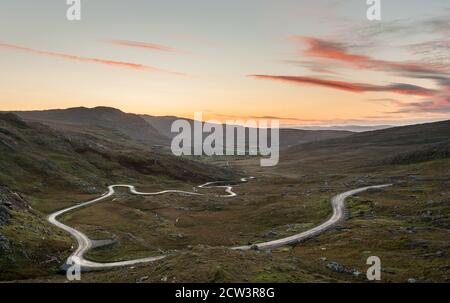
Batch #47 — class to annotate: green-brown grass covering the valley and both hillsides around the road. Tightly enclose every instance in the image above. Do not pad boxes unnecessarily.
[0,114,450,282]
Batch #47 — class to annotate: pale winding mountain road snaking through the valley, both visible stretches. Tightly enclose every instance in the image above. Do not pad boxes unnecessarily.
[47,177,391,271]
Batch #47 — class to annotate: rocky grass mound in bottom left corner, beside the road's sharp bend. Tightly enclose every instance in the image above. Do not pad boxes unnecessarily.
[0,186,71,281]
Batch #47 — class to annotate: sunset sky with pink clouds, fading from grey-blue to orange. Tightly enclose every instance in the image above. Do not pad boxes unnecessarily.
[0,0,450,126]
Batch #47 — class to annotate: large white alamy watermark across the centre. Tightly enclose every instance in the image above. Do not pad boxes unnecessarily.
[171,112,280,166]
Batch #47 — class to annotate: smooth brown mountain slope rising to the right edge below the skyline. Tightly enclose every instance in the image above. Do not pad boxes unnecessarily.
[281,120,450,169]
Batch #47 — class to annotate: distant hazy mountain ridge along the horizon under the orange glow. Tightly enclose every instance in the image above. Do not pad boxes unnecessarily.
[1,106,352,149]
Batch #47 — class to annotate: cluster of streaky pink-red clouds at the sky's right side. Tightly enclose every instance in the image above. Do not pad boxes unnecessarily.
[251,36,450,113]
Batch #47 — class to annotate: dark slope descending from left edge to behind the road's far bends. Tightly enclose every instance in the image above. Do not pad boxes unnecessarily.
[0,114,236,194]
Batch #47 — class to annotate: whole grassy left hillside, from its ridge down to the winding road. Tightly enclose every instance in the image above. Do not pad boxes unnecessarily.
[0,113,237,280]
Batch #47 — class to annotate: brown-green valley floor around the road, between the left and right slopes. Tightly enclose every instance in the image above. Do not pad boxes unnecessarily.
[5,158,450,282]
